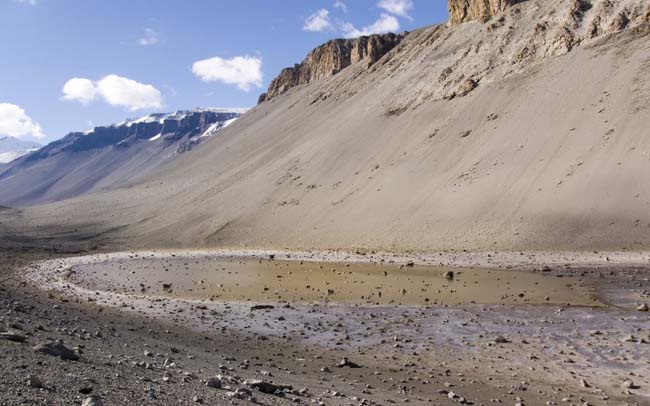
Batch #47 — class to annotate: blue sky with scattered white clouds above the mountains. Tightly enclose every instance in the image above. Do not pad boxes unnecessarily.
[0,0,447,143]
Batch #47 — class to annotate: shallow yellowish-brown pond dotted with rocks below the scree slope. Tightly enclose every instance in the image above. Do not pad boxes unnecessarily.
[69,257,601,306]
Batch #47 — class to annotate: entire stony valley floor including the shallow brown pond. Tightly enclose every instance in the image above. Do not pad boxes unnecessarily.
[0,251,650,405]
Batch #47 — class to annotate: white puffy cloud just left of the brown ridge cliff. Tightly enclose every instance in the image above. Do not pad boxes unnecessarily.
[192,56,263,91]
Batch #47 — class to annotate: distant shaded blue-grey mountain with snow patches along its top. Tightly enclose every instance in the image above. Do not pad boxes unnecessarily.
[0,109,245,206]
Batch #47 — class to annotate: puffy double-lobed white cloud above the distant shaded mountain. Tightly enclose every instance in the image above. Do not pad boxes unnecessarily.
[63,75,163,111]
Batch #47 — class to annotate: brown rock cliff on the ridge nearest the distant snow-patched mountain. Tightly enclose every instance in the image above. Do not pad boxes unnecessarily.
[259,33,403,103]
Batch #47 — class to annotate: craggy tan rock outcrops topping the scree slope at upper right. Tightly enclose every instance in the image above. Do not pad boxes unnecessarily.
[306,0,650,104]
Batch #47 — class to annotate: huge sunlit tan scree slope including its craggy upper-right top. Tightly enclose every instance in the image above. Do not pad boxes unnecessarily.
[2,0,650,251]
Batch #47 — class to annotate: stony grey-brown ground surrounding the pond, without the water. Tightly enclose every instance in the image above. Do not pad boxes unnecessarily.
[0,246,650,405]
